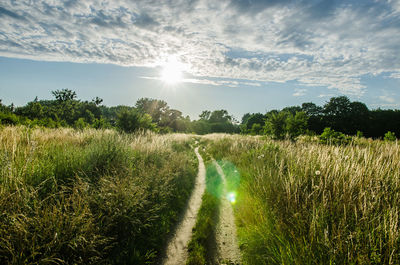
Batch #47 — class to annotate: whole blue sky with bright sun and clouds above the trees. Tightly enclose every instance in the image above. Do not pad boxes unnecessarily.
[0,0,400,119]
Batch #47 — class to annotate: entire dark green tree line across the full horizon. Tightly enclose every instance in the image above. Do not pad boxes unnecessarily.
[0,89,400,139]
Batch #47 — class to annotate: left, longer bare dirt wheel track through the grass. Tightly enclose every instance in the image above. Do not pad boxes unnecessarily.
[163,147,206,265]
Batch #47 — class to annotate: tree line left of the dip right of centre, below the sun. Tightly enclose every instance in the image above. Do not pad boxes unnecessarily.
[0,89,239,134]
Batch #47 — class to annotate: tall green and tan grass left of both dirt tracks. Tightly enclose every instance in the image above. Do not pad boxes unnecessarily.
[0,127,197,264]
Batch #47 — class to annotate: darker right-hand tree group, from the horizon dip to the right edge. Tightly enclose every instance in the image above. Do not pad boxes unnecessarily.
[240,96,400,139]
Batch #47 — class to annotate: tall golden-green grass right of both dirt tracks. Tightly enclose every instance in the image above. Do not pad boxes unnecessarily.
[206,135,400,264]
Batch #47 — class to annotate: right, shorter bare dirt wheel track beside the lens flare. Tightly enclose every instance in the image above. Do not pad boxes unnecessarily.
[214,161,241,264]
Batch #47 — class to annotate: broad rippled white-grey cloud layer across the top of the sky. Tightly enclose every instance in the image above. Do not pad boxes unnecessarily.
[0,0,400,96]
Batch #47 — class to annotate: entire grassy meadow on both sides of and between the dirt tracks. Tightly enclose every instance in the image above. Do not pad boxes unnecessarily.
[0,126,400,264]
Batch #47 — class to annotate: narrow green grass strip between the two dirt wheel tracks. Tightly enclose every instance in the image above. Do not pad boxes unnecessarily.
[186,162,222,265]
